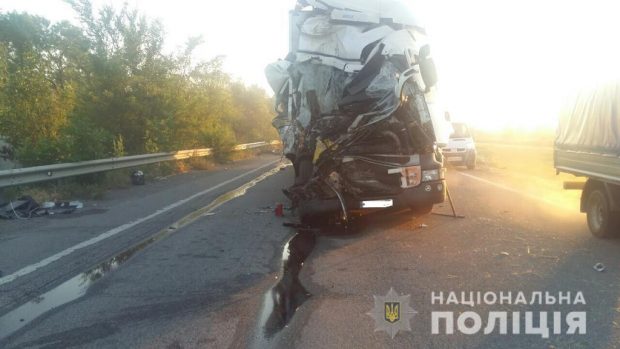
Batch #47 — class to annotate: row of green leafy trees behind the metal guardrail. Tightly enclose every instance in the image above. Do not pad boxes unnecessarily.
[0,0,276,166]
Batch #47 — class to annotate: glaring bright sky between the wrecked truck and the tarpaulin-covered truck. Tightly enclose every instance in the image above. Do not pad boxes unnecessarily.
[414,0,620,130]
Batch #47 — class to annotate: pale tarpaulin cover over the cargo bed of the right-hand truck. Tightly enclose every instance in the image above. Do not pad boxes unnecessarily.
[555,82,620,156]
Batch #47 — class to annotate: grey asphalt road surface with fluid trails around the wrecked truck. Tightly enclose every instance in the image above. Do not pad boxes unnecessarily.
[0,156,620,348]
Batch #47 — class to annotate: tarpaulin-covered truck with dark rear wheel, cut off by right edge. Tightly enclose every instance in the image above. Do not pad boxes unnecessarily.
[554,82,620,238]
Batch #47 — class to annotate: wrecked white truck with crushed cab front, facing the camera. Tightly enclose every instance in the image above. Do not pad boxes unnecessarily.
[266,0,450,223]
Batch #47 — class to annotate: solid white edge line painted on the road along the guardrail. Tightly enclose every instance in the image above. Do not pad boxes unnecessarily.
[0,160,280,285]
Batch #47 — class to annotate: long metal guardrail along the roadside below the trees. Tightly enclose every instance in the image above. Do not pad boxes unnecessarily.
[0,142,274,188]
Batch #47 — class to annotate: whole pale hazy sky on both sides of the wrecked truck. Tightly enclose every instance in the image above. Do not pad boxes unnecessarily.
[0,0,620,129]
